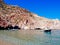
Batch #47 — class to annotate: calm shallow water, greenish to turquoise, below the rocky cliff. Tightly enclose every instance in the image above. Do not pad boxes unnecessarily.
[0,30,60,45]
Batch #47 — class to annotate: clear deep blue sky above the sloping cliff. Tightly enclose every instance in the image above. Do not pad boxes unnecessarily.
[4,0,60,19]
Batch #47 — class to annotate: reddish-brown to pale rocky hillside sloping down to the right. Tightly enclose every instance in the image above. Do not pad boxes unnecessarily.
[0,0,60,29]
